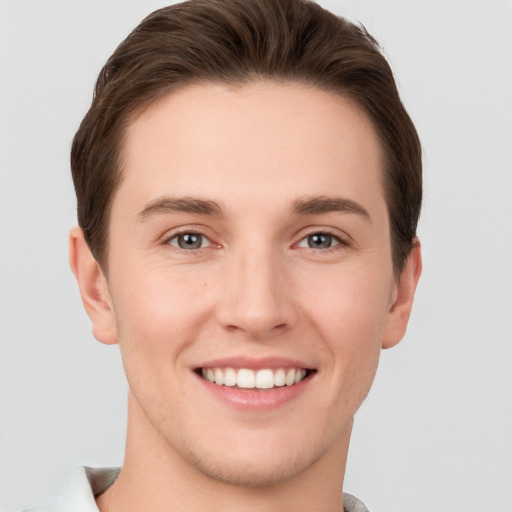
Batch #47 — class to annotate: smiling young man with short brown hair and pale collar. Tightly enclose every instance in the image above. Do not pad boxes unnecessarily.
[26,0,421,512]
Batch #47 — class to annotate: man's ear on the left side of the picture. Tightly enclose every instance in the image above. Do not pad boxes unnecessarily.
[69,226,117,345]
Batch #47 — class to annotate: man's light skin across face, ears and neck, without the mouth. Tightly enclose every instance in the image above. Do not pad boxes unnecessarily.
[70,82,421,512]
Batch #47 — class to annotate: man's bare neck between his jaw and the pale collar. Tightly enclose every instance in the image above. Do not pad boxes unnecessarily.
[97,397,351,512]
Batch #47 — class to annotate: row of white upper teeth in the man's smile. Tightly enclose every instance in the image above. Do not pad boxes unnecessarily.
[202,368,306,389]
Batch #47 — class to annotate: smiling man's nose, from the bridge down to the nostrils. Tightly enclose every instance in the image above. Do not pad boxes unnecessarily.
[217,245,298,341]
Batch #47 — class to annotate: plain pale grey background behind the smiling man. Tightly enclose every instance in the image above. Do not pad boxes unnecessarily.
[0,0,512,512]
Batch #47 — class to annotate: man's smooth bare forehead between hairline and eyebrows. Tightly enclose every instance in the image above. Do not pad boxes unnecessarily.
[114,81,383,214]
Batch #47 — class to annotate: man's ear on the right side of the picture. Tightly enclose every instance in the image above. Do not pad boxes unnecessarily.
[382,240,422,348]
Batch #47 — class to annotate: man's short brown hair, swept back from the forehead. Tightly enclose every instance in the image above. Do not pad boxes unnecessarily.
[71,0,422,275]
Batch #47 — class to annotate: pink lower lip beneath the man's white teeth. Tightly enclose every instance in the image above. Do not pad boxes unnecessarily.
[197,374,314,411]
